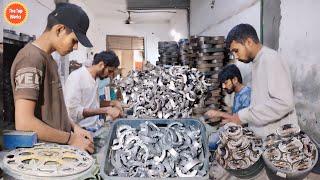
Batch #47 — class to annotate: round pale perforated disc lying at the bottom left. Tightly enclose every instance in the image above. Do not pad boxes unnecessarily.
[3,144,95,179]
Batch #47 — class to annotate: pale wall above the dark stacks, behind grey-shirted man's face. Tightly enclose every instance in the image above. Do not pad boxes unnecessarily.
[190,0,260,86]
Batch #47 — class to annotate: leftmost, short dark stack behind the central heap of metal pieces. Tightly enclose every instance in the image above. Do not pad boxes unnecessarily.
[157,41,179,65]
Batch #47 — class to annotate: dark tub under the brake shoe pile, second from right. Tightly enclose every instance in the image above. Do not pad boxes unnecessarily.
[226,157,264,179]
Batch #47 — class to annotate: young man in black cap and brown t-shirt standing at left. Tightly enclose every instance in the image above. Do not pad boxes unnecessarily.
[11,3,94,153]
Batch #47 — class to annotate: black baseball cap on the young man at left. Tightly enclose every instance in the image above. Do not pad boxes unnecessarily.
[50,3,93,47]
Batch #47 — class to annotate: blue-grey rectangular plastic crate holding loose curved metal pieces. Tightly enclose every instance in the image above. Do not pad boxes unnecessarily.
[98,119,209,180]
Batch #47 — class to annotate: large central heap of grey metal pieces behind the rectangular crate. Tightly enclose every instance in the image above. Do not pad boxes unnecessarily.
[115,66,210,119]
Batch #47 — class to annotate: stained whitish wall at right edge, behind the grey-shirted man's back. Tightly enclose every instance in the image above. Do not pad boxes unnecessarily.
[278,0,320,143]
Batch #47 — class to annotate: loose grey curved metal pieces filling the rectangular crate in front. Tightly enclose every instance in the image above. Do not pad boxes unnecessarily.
[110,121,207,178]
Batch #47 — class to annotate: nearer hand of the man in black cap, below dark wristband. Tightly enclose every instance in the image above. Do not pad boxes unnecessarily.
[68,133,94,153]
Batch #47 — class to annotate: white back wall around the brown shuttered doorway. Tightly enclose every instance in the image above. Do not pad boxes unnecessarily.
[70,0,188,64]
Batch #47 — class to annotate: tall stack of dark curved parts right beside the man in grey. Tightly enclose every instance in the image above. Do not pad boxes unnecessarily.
[190,36,225,114]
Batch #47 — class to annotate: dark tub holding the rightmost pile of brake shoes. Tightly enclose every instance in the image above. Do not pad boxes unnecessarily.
[262,149,318,180]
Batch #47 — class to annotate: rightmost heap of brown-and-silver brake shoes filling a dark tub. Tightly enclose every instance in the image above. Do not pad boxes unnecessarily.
[263,124,317,171]
